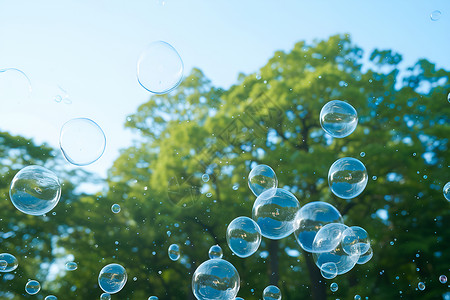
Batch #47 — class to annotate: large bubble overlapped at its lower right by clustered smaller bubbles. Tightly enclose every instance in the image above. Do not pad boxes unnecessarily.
[294,201,344,252]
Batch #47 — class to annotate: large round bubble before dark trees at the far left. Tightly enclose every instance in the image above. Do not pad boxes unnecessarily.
[9,166,61,216]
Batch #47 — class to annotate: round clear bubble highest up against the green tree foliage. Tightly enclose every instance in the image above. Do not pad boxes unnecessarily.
[320,100,358,138]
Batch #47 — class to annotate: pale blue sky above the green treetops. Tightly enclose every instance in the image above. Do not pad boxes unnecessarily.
[0,0,450,176]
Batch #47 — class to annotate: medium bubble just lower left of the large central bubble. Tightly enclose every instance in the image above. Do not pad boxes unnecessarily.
[227,217,261,258]
